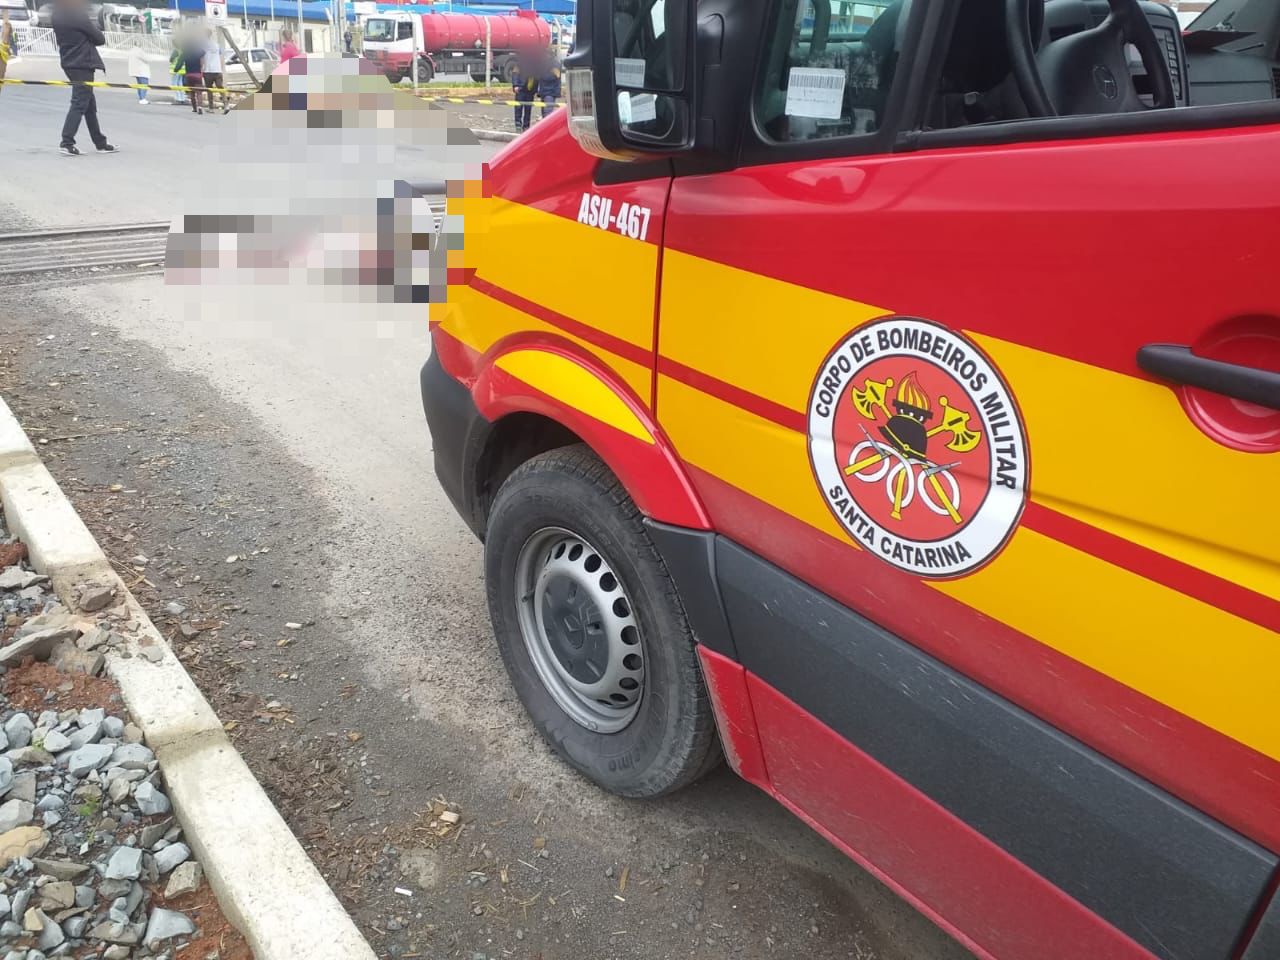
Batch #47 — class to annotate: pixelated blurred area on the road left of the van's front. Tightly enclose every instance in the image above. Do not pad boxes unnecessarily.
[165,54,484,308]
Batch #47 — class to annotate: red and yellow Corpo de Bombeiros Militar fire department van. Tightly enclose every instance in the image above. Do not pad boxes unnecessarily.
[422,0,1280,960]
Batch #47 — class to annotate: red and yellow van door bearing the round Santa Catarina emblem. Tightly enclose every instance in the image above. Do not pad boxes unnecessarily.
[657,0,1280,959]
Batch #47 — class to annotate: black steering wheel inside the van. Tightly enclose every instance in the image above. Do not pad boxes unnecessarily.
[1005,0,1175,116]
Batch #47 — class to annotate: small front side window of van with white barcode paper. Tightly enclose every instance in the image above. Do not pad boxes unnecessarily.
[755,0,906,141]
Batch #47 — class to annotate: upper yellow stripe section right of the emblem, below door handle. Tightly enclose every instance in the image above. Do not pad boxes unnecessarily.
[969,333,1280,601]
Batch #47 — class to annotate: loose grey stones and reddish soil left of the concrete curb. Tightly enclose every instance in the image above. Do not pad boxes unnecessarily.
[0,520,250,960]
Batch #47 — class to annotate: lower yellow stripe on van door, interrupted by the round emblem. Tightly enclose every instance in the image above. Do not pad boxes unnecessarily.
[658,376,1280,759]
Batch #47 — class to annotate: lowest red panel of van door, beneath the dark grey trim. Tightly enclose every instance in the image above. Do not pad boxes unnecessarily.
[746,675,1152,960]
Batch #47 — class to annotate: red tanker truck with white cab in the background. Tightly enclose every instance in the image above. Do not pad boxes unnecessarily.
[365,10,552,82]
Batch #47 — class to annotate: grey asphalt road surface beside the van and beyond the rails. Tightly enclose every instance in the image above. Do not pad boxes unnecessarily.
[0,71,968,960]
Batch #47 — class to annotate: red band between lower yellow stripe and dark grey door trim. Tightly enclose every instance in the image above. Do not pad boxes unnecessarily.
[690,467,1280,849]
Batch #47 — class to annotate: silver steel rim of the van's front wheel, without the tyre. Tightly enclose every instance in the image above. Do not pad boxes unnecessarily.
[516,527,645,733]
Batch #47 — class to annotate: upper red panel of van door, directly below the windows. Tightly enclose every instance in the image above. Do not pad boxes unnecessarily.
[667,127,1280,376]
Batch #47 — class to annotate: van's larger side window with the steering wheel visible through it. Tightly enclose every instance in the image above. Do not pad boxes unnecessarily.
[927,0,1280,129]
